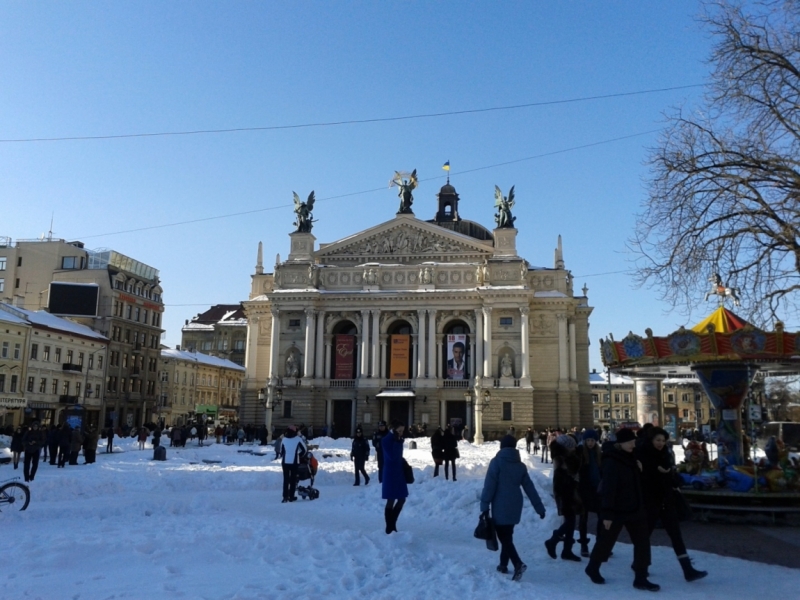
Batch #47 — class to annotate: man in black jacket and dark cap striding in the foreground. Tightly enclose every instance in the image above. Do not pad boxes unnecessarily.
[585,429,661,592]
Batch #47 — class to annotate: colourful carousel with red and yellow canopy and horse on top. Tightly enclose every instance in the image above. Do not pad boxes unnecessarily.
[600,284,800,522]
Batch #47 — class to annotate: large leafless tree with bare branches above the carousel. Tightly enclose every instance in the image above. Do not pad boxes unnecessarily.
[629,0,800,323]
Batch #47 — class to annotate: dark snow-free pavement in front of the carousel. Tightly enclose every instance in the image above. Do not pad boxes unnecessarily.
[576,518,800,569]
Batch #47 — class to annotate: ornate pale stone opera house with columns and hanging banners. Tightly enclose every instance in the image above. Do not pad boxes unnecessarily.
[240,183,593,441]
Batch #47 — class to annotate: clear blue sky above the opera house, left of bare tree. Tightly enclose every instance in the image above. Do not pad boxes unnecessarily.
[0,0,736,368]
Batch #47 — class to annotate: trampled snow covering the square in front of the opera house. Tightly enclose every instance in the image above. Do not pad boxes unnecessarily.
[0,438,800,600]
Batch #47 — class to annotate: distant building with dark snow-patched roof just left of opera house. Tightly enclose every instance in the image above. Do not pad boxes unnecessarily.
[181,303,247,366]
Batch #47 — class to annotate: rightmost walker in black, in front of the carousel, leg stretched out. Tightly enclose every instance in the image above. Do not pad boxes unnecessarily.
[636,427,708,581]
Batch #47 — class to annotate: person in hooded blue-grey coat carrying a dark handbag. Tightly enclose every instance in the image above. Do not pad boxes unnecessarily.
[481,435,545,581]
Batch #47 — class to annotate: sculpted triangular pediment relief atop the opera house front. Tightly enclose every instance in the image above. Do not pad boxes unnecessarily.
[317,220,492,261]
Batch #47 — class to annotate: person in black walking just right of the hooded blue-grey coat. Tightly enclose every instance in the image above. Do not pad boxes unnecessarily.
[544,434,581,562]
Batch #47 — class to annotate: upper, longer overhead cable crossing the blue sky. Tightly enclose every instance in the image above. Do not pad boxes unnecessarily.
[0,83,704,144]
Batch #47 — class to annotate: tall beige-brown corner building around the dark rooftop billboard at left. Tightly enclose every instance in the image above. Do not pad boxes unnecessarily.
[0,238,164,428]
